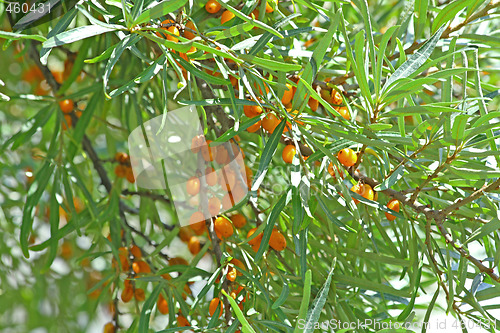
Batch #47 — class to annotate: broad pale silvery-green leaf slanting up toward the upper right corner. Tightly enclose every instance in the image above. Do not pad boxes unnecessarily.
[382,25,445,93]
